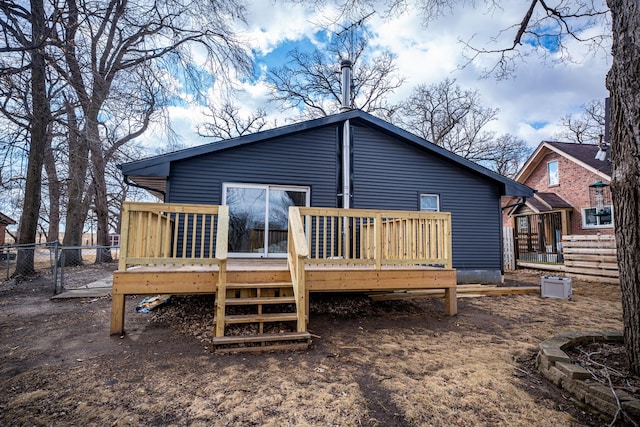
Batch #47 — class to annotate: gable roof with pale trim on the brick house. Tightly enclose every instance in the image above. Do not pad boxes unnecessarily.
[515,141,611,183]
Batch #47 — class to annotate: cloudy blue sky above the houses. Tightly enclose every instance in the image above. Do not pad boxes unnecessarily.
[146,0,610,154]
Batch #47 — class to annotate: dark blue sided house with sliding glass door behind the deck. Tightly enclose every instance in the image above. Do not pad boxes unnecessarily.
[120,110,533,283]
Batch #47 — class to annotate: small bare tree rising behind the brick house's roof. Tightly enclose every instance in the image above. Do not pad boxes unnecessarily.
[555,99,604,144]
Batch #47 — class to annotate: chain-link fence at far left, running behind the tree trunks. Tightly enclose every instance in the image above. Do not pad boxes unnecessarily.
[0,242,120,294]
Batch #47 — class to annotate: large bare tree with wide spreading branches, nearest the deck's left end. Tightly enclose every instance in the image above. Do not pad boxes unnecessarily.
[42,0,248,260]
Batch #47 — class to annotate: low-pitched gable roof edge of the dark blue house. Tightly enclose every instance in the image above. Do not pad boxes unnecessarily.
[118,110,533,198]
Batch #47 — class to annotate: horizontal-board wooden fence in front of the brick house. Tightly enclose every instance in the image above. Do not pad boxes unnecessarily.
[562,235,619,284]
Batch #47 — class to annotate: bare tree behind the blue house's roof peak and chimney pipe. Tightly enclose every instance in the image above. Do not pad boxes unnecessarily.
[267,25,404,118]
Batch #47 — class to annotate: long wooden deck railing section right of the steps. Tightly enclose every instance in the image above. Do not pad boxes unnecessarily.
[290,207,452,269]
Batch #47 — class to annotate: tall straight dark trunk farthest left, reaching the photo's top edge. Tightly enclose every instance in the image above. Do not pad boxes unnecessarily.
[15,0,50,275]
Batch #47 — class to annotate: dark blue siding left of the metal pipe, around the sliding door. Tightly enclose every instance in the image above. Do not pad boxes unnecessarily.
[167,126,337,207]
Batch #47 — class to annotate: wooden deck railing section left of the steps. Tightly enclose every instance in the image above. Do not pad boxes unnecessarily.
[118,202,229,271]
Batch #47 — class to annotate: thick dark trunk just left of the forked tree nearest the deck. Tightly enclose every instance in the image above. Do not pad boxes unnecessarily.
[62,102,89,265]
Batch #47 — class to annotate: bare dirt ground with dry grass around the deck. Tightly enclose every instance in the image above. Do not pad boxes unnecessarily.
[0,269,622,426]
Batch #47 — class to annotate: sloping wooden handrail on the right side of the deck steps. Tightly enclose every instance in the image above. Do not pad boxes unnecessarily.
[287,206,309,332]
